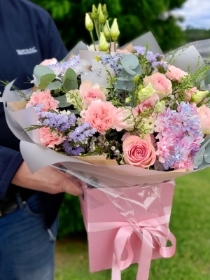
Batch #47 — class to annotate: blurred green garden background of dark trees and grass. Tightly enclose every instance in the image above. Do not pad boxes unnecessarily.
[32,0,210,280]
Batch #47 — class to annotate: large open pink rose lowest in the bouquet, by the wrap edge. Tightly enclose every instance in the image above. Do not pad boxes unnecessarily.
[123,135,156,168]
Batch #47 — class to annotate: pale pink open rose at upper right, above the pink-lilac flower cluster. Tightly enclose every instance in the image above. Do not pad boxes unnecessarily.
[143,73,172,99]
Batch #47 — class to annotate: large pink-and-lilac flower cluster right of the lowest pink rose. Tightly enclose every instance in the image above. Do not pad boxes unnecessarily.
[155,102,204,170]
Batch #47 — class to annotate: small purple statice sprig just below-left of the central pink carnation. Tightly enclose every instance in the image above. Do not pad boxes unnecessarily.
[69,123,97,143]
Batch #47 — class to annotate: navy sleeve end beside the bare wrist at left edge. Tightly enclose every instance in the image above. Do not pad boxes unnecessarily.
[0,146,23,200]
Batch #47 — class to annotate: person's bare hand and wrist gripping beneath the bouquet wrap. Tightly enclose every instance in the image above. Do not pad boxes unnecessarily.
[12,162,82,195]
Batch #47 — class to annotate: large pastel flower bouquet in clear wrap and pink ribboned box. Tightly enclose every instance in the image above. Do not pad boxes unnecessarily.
[4,4,210,280]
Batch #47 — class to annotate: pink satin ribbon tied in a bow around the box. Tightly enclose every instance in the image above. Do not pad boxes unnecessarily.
[88,215,176,280]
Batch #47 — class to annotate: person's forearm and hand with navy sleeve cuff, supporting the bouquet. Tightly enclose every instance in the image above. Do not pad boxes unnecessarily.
[0,146,82,200]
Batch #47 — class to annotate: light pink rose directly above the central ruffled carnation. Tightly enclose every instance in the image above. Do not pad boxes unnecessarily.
[79,81,106,107]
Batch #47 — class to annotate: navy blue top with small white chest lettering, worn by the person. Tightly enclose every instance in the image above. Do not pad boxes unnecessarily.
[0,0,67,227]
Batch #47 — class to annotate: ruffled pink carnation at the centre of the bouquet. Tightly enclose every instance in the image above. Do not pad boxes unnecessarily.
[80,100,117,134]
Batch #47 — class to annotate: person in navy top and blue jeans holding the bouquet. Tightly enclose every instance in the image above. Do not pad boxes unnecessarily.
[0,0,81,280]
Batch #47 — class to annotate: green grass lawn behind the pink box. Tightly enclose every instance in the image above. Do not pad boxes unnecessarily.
[55,169,210,280]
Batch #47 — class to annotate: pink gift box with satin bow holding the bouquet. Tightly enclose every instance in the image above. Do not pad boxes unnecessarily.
[80,181,176,280]
